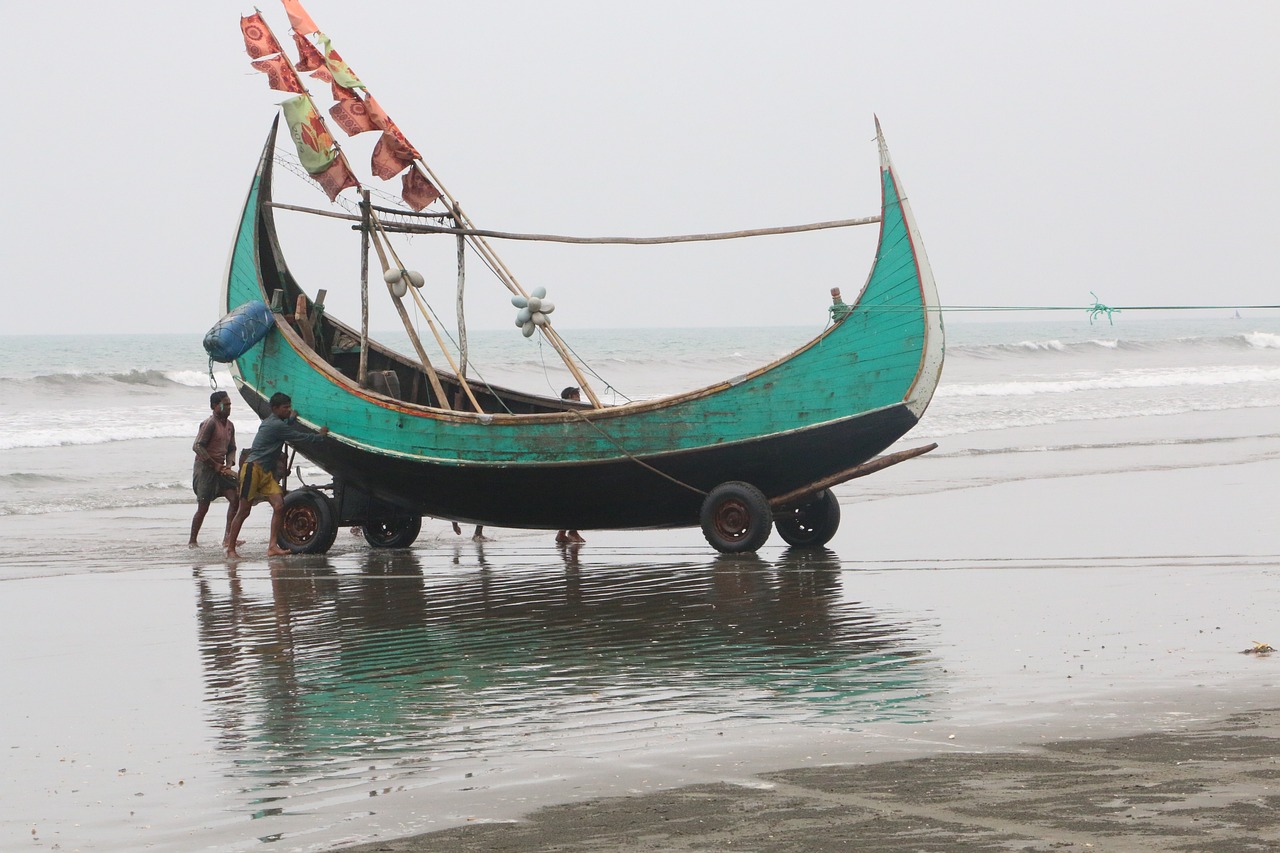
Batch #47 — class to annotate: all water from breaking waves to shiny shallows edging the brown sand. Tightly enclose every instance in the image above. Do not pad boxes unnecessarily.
[0,310,1280,853]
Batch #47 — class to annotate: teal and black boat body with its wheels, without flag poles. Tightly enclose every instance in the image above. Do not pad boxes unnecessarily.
[224,111,943,552]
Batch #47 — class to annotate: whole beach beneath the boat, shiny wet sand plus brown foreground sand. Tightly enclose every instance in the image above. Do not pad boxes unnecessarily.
[0,409,1280,850]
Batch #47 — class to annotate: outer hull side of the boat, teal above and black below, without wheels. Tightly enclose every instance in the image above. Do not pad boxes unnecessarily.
[224,117,942,529]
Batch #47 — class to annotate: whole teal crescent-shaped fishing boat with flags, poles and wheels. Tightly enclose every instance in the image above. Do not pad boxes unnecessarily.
[217,0,943,552]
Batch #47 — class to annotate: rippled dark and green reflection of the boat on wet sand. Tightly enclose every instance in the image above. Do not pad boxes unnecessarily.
[198,552,932,772]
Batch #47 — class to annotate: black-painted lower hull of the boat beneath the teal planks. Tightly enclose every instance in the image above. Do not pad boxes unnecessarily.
[242,386,916,530]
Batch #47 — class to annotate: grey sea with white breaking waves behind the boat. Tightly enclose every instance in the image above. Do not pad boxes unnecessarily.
[0,311,1280,517]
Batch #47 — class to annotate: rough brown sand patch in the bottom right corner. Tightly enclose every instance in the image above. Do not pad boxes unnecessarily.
[346,710,1280,853]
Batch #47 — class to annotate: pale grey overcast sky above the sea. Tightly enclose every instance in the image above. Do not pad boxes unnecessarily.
[0,0,1280,334]
